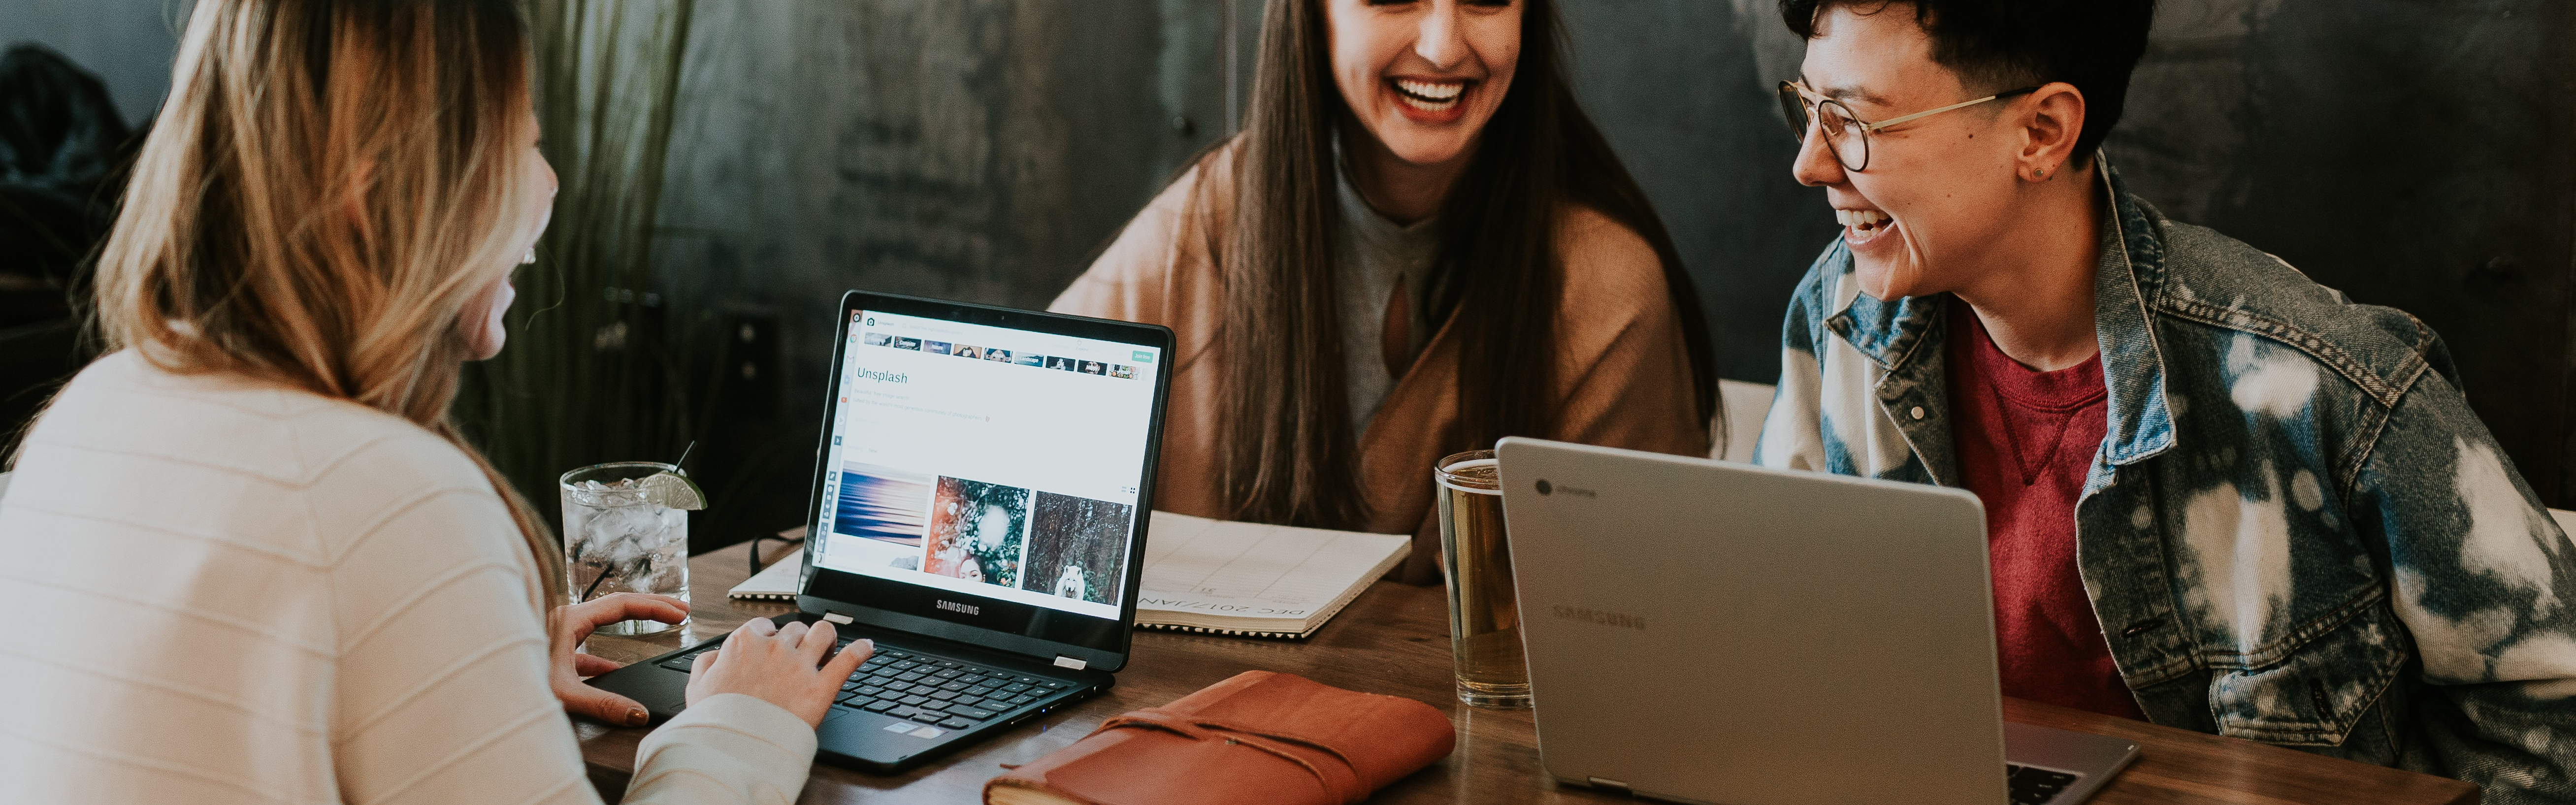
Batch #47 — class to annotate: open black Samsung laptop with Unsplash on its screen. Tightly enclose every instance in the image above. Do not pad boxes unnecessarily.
[590,290,1172,772]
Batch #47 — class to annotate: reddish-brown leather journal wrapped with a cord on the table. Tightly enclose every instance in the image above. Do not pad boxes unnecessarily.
[984,671,1458,805]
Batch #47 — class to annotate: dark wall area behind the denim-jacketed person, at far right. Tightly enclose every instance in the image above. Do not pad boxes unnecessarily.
[2110,0,2576,504]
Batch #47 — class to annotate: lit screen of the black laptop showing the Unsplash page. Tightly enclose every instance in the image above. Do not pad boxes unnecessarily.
[814,311,1162,617]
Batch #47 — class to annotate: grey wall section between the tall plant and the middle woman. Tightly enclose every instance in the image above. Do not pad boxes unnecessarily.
[657,0,1249,535]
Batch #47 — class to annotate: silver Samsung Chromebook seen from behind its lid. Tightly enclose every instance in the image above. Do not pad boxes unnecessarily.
[1497,437,2138,805]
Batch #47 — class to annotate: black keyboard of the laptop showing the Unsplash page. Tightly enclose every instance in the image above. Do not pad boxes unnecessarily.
[662,641,1072,731]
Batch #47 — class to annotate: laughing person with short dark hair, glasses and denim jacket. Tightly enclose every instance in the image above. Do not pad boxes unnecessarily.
[1754,0,2576,803]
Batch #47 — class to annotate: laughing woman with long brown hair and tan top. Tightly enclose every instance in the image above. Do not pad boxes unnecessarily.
[1053,0,1716,584]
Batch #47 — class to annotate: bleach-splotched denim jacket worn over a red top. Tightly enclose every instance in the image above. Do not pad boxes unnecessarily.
[1754,162,2576,805]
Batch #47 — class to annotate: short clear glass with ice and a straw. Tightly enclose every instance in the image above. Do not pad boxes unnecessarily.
[559,460,688,635]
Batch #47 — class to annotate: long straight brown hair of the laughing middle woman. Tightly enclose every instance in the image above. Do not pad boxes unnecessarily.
[1201,0,1716,527]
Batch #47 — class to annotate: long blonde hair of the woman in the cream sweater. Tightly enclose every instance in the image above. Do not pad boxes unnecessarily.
[98,0,567,602]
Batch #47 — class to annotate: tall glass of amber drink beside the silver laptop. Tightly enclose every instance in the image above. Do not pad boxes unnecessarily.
[1432,450,1530,710]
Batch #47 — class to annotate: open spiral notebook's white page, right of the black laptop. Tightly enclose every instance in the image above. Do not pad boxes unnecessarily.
[1136,512,1414,638]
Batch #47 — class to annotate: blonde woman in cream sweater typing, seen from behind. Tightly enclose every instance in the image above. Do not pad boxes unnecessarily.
[0,0,868,803]
